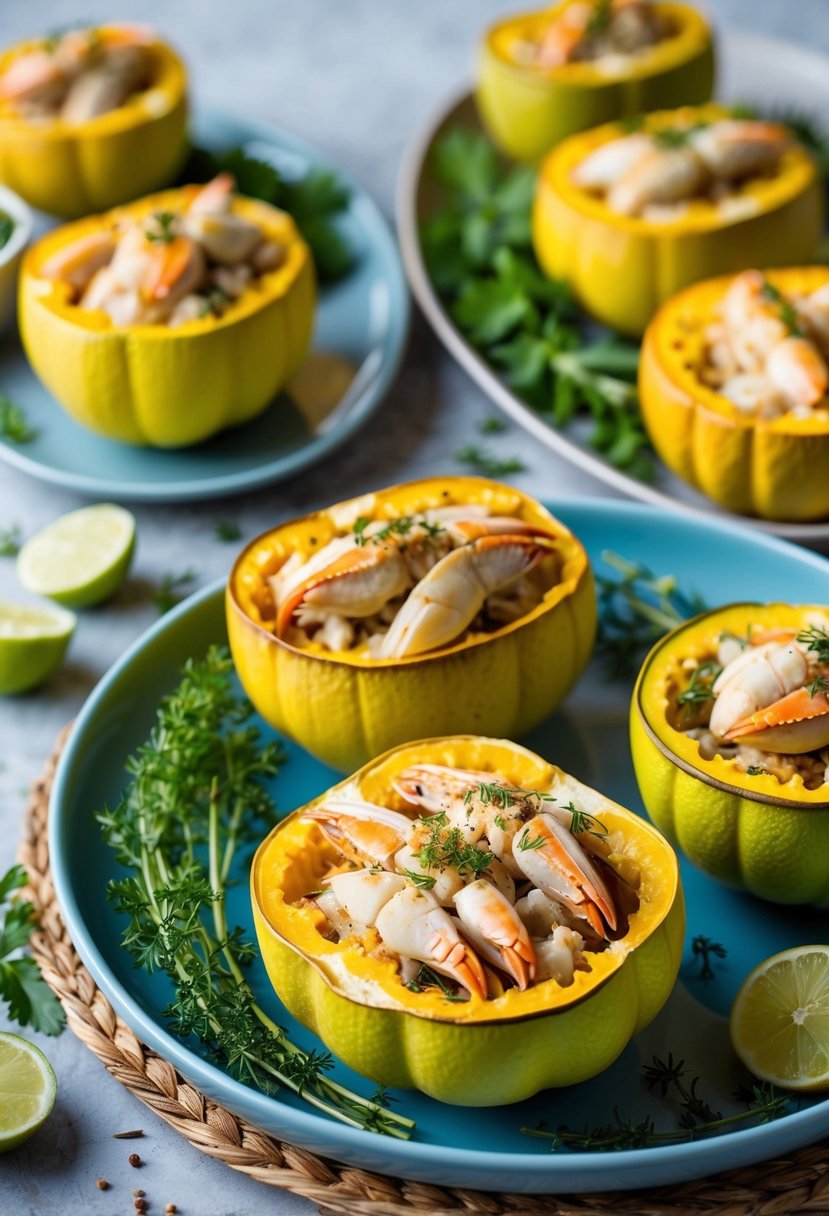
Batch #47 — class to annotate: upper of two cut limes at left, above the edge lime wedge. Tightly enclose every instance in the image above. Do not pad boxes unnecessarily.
[17,502,135,608]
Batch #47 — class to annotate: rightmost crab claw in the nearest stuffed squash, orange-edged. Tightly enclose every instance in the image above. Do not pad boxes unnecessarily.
[513,814,617,938]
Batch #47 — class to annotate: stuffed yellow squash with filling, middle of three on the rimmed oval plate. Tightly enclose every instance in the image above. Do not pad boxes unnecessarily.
[532,106,823,334]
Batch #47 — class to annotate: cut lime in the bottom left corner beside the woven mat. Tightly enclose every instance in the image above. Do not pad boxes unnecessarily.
[0,1030,57,1153]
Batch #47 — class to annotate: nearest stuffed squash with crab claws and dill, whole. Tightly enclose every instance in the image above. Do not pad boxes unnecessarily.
[250,736,684,1105]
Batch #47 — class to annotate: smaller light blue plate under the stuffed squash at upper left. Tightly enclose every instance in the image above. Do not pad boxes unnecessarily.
[0,107,410,502]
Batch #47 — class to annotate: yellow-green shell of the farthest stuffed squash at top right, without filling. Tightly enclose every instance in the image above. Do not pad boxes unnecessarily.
[475,0,715,162]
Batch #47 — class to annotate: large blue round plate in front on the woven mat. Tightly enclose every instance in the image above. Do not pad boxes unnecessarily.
[50,500,829,1193]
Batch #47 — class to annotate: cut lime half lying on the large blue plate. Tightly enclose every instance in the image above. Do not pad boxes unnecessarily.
[731,946,829,1090]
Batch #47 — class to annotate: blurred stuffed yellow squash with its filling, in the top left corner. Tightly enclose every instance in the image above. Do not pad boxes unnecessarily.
[0,24,187,219]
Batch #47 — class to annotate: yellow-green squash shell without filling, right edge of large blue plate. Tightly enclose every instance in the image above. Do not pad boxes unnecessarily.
[631,603,829,907]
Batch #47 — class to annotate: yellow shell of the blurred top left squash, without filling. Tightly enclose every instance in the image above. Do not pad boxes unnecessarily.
[0,26,187,219]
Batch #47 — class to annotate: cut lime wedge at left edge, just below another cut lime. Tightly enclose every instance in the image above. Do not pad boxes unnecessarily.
[0,601,77,697]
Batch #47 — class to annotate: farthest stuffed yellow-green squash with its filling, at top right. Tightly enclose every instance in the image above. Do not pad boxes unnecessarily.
[475,0,714,161]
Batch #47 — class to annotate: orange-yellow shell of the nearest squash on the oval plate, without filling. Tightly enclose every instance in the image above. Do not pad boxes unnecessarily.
[639,266,829,522]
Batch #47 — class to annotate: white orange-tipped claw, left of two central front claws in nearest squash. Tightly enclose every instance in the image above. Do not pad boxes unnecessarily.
[374,886,486,1001]
